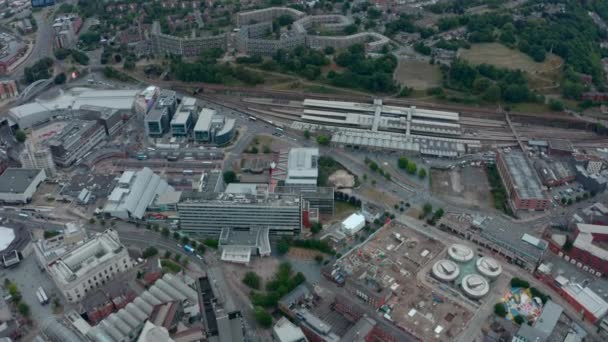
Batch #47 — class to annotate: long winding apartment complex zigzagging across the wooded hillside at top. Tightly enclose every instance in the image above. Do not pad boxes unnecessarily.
[150,7,390,57]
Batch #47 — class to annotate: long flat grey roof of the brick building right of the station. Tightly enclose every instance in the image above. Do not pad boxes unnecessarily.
[500,151,545,199]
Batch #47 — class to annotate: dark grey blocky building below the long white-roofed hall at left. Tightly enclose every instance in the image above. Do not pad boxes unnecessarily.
[47,120,106,167]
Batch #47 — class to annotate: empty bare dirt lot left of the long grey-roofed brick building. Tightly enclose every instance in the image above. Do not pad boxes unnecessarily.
[431,166,493,209]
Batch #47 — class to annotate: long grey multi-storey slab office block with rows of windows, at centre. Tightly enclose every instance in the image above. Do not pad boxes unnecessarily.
[177,191,308,236]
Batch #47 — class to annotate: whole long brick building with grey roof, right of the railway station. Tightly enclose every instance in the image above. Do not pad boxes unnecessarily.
[496,151,550,210]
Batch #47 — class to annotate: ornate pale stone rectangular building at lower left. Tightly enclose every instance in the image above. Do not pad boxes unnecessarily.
[45,229,133,303]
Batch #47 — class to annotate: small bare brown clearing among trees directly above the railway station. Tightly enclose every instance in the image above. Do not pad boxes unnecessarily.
[394,58,441,90]
